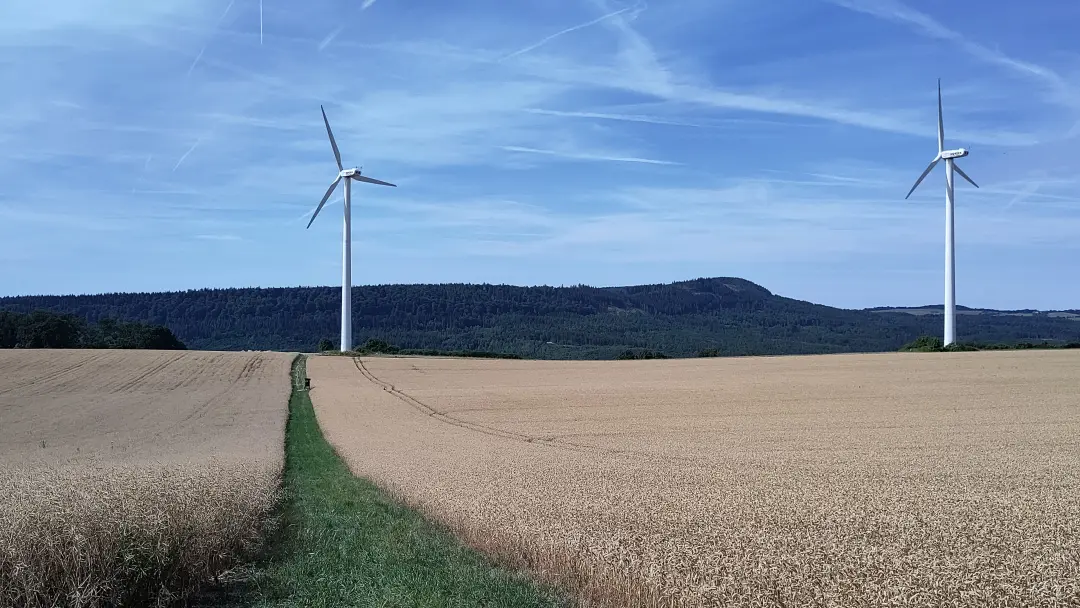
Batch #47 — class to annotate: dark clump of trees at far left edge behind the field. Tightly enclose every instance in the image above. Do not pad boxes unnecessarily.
[0,310,186,350]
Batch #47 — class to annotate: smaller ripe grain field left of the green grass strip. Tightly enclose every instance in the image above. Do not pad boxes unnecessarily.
[0,350,293,606]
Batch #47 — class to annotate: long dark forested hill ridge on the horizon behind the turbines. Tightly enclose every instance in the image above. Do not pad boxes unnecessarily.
[0,278,1080,359]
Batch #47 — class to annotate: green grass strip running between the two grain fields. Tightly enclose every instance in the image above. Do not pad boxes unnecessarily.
[219,356,565,608]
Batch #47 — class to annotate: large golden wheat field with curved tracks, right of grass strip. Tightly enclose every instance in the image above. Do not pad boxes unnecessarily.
[308,351,1080,607]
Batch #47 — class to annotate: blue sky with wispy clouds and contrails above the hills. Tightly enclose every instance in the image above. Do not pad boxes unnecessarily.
[0,0,1080,308]
